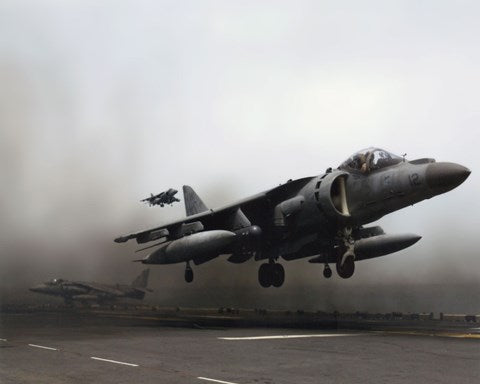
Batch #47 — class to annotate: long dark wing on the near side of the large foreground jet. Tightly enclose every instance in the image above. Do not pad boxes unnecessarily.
[115,177,312,243]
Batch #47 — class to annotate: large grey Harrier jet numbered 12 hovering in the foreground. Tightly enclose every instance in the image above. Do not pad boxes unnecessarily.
[115,148,470,287]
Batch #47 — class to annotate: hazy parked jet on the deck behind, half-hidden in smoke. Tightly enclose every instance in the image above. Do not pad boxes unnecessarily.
[30,269,152,304]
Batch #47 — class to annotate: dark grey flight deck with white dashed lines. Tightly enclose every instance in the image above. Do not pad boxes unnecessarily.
[0,306,480,384]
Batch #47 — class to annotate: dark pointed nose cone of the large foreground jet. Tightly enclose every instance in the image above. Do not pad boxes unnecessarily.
[425,163,470,191]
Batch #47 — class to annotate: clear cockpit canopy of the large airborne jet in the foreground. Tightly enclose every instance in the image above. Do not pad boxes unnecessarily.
[338,147,404,173]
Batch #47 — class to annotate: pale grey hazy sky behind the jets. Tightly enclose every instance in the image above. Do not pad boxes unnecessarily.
[0,0,480,312]
